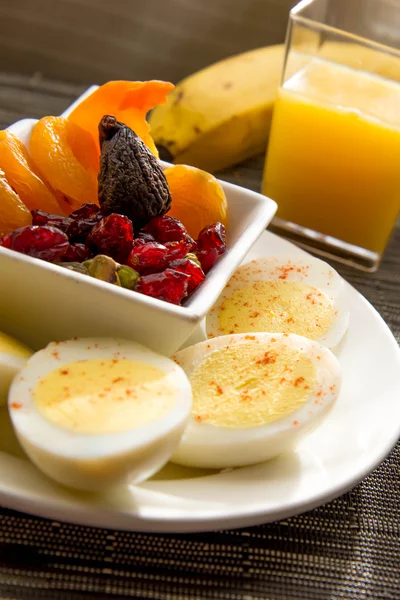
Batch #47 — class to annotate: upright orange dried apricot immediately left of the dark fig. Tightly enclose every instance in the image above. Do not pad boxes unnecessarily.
[29,117,99,213]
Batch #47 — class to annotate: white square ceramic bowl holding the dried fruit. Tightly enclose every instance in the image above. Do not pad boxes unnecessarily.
[0,88,277,355]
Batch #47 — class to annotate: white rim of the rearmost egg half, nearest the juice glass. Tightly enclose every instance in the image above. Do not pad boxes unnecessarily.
[206,254,349,349]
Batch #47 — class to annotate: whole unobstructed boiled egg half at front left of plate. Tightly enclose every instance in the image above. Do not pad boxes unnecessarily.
[9,338,192,491]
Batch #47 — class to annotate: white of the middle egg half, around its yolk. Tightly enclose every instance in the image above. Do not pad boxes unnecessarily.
[171,333,341,469]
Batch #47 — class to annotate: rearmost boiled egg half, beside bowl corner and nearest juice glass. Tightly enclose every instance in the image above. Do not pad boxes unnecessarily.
[206,255,349,349]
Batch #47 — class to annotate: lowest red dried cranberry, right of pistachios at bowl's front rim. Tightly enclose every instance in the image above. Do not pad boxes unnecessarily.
[135,269,190,304]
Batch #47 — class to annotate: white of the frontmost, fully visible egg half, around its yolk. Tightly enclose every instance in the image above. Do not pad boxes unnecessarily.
[9,338,192,491]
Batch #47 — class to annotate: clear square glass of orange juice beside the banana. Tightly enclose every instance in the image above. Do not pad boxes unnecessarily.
[263,0,400,271]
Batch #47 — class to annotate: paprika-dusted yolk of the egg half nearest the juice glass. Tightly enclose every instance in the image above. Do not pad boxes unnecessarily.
[218,281,335,340]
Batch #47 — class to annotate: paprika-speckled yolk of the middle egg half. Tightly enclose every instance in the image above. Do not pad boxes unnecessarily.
[191,341,317,428]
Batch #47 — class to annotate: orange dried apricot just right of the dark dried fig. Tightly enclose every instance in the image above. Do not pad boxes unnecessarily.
[164,165,228,239]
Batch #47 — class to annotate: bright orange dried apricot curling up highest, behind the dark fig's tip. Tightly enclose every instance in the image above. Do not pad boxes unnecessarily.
[68,81,174,156]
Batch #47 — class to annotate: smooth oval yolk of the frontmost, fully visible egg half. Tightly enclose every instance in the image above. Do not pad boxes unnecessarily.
[33,359,176,434]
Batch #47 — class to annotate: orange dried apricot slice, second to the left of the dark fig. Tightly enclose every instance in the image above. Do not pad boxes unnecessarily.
[0,130,63,214]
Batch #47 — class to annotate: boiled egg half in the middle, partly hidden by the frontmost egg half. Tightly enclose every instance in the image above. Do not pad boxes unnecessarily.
[171,333,341,469]
